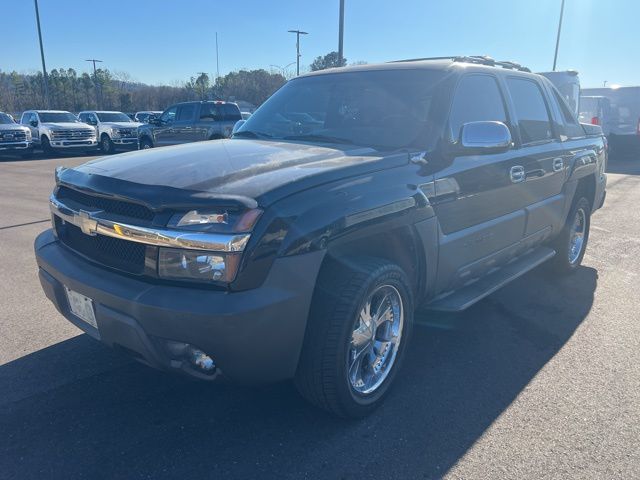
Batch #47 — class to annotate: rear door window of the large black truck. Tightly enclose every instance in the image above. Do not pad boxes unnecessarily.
[507,77,553,144]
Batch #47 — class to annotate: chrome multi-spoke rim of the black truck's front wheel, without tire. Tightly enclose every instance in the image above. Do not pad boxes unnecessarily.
[347,285,404,395]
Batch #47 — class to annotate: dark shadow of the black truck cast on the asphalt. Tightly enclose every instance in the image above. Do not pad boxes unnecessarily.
[0,267,597,479]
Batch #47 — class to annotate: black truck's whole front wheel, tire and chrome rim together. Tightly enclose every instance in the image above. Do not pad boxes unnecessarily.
[295,259,413,418]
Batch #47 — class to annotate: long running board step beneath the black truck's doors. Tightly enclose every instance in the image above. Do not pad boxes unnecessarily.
[423,247,556,312]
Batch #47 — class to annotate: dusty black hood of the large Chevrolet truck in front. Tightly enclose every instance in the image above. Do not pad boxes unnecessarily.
[67,139,408,208]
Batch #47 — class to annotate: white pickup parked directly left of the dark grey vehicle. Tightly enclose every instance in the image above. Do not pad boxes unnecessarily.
[78,110,142,153]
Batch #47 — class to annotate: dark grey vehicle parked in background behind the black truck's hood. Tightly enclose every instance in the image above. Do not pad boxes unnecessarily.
[138,101,242,149]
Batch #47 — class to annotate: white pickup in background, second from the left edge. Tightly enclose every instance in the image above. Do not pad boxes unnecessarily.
[20,110,98,153]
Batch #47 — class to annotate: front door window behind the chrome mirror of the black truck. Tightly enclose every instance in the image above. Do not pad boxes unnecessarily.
[449,75,507,141]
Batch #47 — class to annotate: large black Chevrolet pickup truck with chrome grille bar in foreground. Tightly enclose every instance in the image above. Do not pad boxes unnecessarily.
[35,57,607,416]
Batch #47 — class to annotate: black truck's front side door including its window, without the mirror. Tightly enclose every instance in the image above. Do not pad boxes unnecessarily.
[432,73,526,292]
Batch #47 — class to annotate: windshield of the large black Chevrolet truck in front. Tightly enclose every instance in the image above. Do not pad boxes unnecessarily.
[236,70,445,149]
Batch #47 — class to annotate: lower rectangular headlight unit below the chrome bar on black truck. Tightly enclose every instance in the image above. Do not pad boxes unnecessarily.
[158,248,240,283]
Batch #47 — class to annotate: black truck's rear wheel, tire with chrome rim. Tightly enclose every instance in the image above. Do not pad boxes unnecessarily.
[551,197,591,274]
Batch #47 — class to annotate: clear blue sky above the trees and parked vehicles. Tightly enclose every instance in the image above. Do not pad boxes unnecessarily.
[0,0,640,86]
